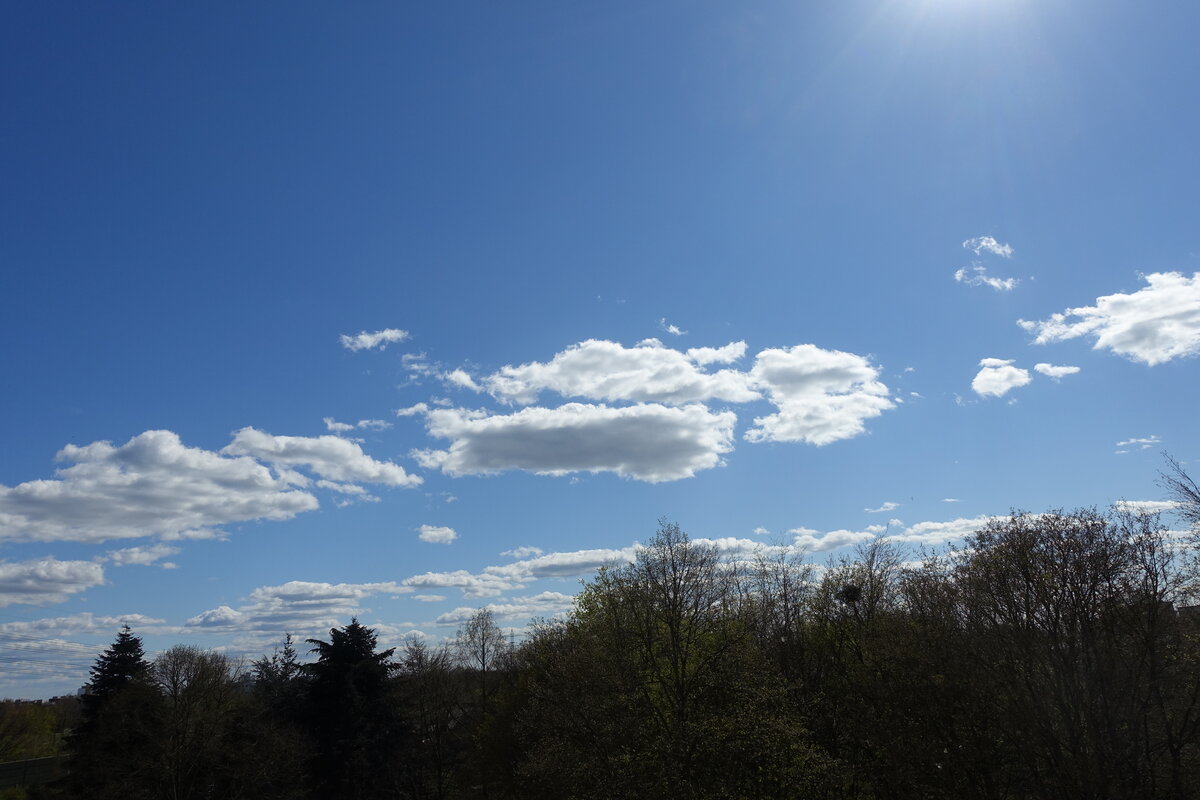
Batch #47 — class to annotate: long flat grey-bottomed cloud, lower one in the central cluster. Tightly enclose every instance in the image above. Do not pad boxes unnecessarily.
[414,403,737,483]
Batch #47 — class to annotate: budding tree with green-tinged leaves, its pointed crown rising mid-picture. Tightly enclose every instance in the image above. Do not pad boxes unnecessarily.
[521,521,828,799]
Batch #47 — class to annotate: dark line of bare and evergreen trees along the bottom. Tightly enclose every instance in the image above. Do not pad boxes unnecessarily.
[16,470,1200,800]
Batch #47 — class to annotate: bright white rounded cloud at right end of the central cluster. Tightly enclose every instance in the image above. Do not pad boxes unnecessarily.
[745,344,895,446]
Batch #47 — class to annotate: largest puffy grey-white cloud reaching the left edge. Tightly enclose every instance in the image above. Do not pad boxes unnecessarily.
[0,431,319,542]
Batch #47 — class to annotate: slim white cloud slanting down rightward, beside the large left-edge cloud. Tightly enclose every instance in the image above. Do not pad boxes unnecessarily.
[221,427,421,487]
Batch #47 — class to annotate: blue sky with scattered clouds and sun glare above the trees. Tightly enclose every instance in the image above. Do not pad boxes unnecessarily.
[0,0,1200,697]
